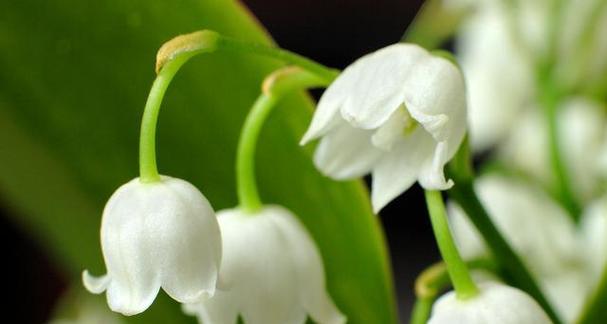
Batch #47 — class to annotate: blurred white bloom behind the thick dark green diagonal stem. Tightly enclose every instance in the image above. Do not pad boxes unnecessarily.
[449,175,592,320]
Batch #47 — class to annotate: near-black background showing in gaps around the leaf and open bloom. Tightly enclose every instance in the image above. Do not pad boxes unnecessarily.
[0,0,439,323]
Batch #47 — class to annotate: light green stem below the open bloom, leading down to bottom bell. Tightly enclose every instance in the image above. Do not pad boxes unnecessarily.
[425,190,478,299]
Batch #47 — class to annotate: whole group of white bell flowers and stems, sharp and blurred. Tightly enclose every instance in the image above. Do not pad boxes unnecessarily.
[83,0,607,324]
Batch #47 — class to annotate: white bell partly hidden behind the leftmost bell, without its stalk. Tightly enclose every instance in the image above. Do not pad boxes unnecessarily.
[184,206,345,324]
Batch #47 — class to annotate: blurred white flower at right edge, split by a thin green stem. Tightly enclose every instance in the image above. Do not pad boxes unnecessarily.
[498,97,607,202]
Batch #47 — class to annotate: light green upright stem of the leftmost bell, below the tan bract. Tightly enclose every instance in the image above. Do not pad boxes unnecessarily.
[139,59,186,182]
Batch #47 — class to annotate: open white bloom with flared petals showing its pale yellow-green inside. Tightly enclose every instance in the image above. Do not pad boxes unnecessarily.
[302,44,466,211]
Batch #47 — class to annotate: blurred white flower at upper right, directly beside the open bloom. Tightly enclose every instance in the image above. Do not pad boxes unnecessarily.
[456,1,534,150]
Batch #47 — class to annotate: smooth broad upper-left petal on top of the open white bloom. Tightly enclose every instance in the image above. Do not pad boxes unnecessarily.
[339,44,430,129]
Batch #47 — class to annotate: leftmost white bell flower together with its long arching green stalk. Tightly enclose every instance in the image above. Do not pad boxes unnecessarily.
[83,30,337,315]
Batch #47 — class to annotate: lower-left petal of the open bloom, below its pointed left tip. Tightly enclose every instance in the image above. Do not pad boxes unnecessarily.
[314,122,381,180]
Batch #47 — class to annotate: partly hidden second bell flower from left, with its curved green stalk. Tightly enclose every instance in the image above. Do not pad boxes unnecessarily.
[184,67,345,324]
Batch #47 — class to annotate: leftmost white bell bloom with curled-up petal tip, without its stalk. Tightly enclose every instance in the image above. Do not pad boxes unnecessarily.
[83,176,221,315]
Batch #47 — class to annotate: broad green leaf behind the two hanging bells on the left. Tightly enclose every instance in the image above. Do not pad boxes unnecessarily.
[0,0,396,323]
